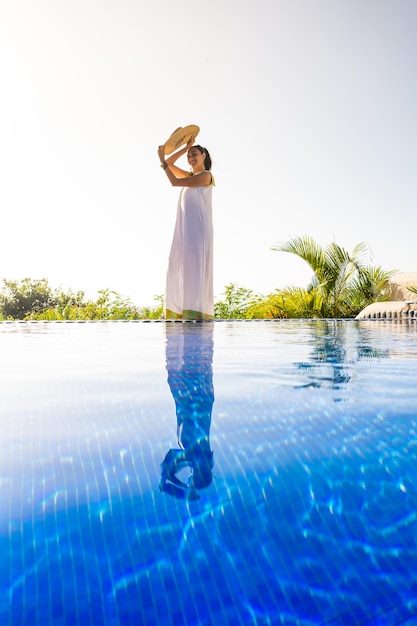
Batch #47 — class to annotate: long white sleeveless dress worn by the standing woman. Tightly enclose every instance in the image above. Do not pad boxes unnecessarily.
[165,173,214,320]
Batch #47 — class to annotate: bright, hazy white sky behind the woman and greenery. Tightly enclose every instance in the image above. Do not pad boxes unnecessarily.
[0,0,417,305]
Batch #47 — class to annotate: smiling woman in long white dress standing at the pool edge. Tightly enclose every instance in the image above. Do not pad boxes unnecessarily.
[158,137,214,320]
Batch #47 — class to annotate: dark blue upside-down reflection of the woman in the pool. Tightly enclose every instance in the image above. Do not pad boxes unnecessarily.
[159,322,214,499]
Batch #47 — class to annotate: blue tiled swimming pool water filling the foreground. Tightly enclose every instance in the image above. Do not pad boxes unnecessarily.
[0,320,417,626]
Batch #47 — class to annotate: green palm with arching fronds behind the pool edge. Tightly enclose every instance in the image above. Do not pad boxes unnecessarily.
[272,236,393,317]
